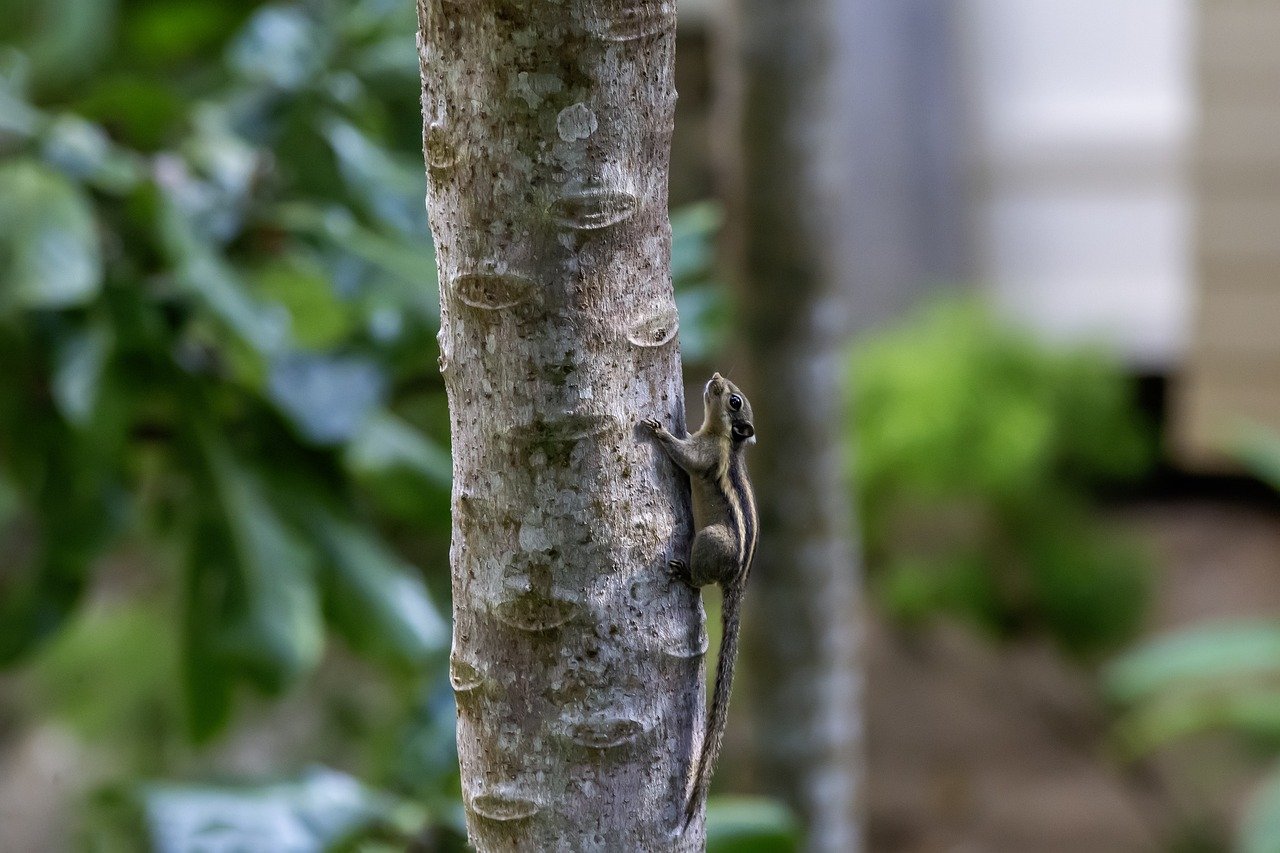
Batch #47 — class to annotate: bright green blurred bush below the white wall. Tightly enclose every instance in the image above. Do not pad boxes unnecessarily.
[849,298,1151,656]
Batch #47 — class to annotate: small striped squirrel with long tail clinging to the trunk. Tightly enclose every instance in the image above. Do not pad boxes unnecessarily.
[641,373,759,827]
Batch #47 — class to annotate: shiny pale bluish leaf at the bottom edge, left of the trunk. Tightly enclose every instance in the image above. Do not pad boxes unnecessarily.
[142,767,393,853]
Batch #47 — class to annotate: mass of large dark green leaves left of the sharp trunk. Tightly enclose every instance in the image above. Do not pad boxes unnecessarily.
[0,3,448,740]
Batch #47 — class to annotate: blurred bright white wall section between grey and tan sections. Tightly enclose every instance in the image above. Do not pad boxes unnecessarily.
[956,0,1196,370]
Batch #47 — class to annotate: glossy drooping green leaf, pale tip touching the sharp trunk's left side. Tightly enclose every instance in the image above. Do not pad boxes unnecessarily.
[311,510,449,666]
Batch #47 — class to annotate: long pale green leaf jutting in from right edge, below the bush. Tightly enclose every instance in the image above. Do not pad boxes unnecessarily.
[1103,620,1280,703]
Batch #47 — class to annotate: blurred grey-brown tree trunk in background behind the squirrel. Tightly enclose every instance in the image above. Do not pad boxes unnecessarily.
[717,0,863,853]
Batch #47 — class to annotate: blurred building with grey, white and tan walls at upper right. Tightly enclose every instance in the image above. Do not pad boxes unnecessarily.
[677,0,1280,467]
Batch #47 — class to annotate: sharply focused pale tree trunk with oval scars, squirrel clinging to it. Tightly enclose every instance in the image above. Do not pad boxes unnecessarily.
[419,0,707,850]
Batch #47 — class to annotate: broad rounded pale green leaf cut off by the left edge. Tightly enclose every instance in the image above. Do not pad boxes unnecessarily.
[0,160,102,309]
